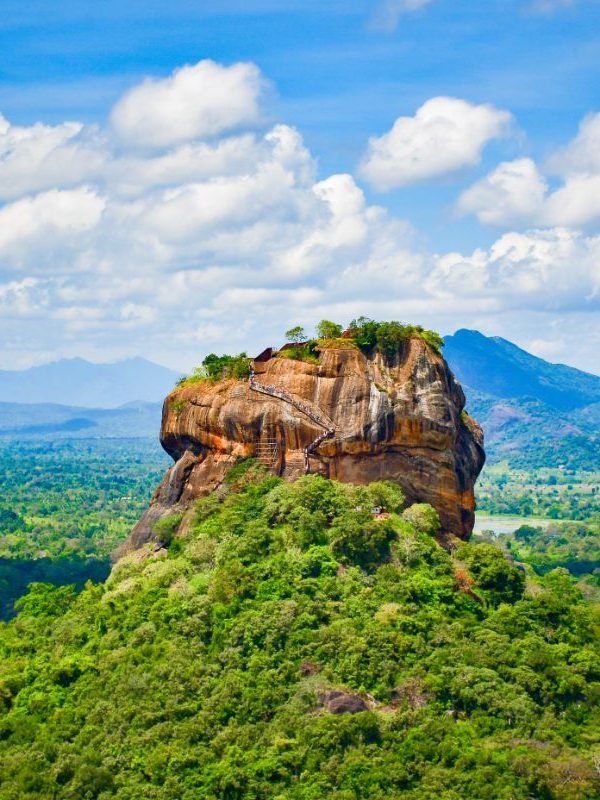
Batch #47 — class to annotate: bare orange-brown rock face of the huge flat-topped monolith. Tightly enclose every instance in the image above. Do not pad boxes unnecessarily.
[125,337,485,550]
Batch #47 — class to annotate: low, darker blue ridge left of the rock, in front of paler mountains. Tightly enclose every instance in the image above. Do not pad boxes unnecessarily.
[0,402,162,438]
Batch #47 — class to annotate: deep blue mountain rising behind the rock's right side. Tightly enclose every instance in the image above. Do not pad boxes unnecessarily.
[444,330,600,470]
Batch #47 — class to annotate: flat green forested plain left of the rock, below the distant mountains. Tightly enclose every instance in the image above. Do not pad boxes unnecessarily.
[0,438,170,619]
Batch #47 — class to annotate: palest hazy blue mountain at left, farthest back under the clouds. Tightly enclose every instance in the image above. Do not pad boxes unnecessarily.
[0,358,180,408]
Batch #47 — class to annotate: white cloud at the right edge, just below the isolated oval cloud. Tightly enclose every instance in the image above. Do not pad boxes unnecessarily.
[457,114,600,226]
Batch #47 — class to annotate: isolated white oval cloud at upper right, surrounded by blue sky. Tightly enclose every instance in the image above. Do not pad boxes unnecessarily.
[360,97,512,191]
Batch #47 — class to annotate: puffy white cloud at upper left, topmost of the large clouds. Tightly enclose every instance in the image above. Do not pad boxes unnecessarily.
[111,60,263,148]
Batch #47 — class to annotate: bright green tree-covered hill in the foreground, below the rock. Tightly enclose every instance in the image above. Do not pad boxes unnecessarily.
[0,462,600,800]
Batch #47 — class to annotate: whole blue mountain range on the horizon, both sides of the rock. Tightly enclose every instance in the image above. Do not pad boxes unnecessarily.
[0,338,600,470]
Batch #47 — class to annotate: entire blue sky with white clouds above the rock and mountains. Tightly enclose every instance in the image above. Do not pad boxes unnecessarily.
[0,0,600,374]
